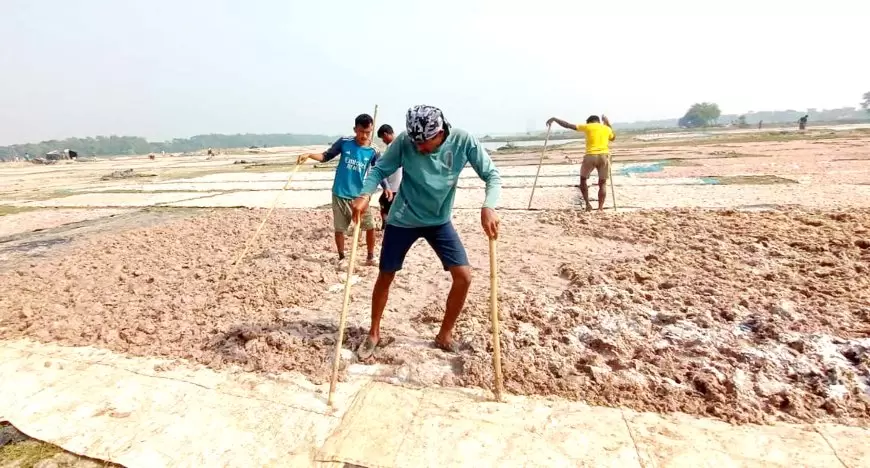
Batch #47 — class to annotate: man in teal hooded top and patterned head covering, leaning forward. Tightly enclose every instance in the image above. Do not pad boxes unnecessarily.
[351,106,501,360]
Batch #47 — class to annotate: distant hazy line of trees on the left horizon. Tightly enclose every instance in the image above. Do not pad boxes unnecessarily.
[0,133,337,159]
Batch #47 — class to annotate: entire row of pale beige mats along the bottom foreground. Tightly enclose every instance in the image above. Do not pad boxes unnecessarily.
[0,340,870,468]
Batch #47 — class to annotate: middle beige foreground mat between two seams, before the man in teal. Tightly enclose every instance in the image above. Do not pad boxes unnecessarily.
[317,383,639,467]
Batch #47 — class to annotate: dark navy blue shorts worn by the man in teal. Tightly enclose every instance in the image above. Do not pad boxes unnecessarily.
[380,223,468,273]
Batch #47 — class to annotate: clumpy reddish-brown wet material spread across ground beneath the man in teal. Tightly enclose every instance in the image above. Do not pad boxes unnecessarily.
[0,210,870,425]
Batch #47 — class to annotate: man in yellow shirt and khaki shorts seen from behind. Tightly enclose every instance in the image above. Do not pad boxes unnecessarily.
[547,115,616,211]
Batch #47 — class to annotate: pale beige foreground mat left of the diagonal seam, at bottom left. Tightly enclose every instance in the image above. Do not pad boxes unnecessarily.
[0,340,364,468]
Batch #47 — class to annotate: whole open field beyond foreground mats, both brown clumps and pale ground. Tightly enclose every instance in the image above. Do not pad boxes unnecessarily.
[0,127,870,464]
